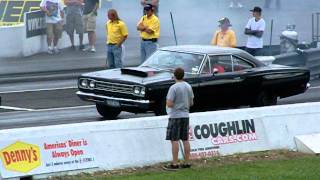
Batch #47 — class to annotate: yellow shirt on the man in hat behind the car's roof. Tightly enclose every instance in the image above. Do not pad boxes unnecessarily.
[211,29,237,47]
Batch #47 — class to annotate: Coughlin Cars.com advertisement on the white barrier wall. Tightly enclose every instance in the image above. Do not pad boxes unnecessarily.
[189,116,269,159]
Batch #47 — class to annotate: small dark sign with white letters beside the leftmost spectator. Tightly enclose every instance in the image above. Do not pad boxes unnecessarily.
[26,11,46,38]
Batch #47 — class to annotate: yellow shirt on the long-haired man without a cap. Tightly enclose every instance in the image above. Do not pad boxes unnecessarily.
[106,20,128,44]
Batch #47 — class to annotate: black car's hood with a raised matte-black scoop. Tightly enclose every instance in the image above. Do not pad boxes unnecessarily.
[82,67,173,84]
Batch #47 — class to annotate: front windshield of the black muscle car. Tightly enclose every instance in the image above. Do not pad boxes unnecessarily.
[141,50,204,73]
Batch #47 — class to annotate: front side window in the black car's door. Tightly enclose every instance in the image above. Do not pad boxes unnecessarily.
[209,55,233,74]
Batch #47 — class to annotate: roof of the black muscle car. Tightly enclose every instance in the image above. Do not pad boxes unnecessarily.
[159,45,265,66]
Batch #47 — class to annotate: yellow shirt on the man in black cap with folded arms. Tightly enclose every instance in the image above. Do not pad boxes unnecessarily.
[138,14,160,39]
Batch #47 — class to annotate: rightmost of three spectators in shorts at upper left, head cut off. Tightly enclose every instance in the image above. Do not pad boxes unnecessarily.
[83,0,99,53]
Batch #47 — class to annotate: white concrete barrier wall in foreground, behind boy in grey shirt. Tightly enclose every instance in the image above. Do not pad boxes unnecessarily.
[0,103,320,177]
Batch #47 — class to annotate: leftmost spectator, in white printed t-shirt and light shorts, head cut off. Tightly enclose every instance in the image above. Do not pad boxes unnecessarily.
[40,0,64,54]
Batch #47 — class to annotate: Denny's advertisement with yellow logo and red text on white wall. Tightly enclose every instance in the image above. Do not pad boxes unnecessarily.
[0,134,97,179]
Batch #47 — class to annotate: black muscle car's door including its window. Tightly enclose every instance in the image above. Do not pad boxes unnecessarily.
[199,54,251,107]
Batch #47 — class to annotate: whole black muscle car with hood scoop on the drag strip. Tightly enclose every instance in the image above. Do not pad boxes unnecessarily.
[77,45,310,119]
